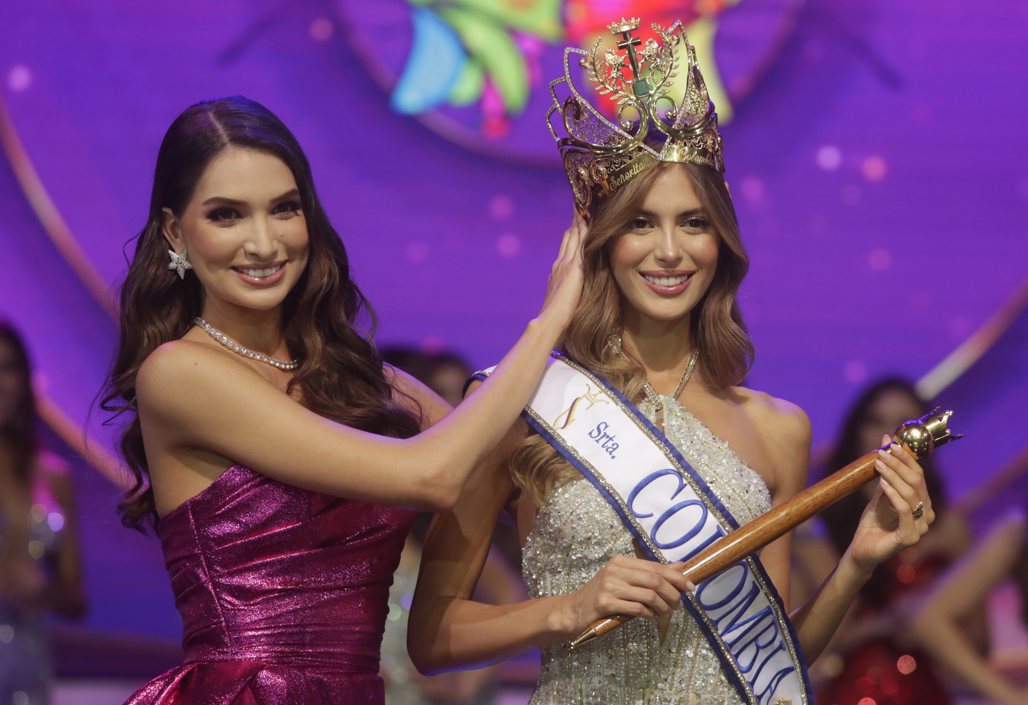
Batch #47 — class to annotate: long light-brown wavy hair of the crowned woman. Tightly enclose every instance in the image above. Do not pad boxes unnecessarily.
[510,163,754,505]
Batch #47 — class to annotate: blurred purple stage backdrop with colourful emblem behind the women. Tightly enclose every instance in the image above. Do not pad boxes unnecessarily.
[0,0,1028,686]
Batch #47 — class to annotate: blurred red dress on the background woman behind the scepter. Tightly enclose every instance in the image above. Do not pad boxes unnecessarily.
[815,548,953,705]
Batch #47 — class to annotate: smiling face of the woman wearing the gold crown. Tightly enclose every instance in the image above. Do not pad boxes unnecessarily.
[608,164,720,329]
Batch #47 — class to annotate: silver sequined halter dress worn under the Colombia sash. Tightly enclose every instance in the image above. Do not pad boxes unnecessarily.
[522,397,771,705]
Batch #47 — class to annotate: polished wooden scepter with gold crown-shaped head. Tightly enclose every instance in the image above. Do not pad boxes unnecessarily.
[571,408,963,648]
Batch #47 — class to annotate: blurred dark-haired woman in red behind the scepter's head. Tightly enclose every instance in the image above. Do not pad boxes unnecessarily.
[810,377,985,705]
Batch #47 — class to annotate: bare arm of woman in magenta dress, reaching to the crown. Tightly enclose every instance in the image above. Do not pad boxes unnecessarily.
[136,217,585,513]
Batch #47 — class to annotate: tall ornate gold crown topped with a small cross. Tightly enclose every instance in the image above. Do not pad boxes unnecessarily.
[546,18,725,212]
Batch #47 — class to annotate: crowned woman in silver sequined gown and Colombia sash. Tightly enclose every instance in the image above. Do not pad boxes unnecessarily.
[408,21,933,705]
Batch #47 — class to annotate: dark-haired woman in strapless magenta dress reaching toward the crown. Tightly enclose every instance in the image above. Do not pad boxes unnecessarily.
[104,98,581,705]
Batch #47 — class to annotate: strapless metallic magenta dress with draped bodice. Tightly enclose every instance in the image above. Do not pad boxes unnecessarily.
[126,466,413,705]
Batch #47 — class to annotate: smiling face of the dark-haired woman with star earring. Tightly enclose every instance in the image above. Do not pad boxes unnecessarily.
[163,146,309,322]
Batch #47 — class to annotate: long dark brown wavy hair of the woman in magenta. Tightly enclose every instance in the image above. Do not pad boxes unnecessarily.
[101,97,420,528]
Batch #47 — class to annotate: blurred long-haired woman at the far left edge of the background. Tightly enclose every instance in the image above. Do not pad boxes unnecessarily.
[0,321,85,705]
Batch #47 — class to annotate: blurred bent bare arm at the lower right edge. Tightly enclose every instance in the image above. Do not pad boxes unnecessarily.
[911,507,1028,705]
